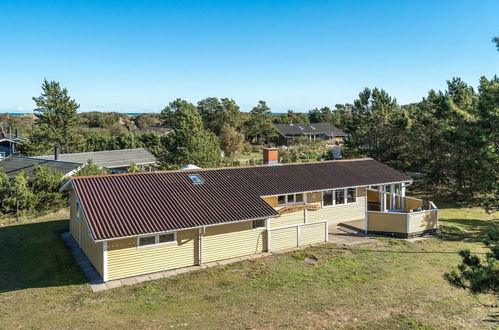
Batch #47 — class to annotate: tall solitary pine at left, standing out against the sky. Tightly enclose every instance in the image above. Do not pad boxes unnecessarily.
[22,79,83,155]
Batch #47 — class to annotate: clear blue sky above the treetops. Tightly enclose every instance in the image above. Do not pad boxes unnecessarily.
[0,0,499,112]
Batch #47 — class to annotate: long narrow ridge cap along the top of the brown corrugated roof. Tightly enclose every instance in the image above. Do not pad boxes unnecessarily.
[71,157,374,180]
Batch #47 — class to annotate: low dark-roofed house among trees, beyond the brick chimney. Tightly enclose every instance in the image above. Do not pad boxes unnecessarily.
[274,123,348,145]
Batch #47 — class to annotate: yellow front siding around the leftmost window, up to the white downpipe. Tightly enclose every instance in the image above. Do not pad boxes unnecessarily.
[107,229,198,280]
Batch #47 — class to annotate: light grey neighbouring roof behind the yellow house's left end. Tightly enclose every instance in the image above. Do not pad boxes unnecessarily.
[37,148,156,168]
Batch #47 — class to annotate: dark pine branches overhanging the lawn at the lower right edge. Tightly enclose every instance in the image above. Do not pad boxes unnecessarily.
[444,220,499,295]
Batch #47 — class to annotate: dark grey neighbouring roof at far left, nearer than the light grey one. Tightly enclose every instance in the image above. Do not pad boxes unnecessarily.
[0,156,81,178]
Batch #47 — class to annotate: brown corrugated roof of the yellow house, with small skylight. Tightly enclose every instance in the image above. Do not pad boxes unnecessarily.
[72,159,411,240]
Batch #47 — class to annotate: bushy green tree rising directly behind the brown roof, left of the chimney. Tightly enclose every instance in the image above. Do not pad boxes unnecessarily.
[158,99,221,169]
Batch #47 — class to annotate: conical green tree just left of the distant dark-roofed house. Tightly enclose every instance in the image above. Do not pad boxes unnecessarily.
[246,101,277,143]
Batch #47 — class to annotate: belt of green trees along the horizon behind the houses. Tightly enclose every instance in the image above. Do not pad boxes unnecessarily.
[4,72,499,211]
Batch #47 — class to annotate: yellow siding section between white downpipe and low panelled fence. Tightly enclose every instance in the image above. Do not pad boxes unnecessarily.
[202,221,265,262]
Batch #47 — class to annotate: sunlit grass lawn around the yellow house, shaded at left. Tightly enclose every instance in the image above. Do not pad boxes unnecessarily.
[0,208,497,329]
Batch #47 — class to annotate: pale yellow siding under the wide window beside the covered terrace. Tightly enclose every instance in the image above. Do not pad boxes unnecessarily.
[307,197,366,224]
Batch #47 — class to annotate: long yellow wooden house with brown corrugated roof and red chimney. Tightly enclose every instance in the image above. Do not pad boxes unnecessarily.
[61,159,436,281]
